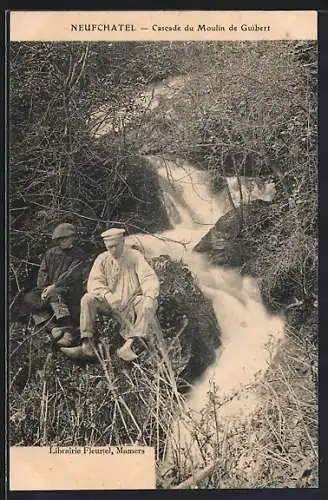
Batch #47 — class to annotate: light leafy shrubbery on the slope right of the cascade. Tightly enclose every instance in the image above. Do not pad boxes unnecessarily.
[144,42,318,328]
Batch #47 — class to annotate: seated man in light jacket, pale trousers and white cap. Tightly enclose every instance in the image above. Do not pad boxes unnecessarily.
[62,229,159,361]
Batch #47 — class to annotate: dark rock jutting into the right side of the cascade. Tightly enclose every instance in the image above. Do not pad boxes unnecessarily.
[194,200,270,267]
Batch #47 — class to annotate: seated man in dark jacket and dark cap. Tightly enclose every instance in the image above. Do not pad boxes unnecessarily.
[19,223,84,347]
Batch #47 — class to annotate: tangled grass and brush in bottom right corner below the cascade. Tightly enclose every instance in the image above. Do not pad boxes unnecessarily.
[163,329,318,489]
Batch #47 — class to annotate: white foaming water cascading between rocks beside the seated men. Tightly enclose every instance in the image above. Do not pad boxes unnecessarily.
[127,156,284,464]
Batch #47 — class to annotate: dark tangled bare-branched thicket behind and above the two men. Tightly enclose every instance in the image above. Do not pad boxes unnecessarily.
[9,43,177,295]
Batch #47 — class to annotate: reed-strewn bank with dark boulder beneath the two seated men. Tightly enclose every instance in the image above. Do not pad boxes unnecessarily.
[10,257,220,449]
